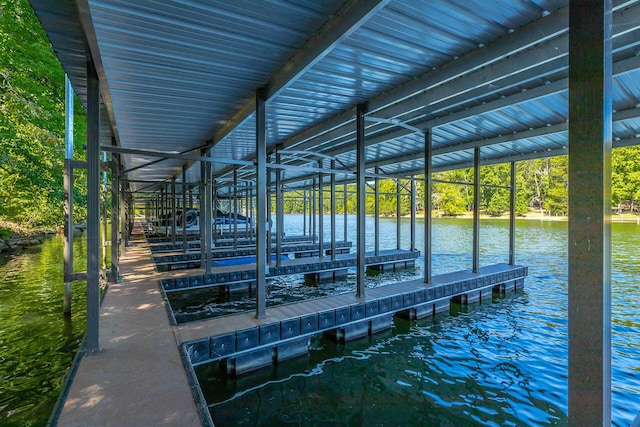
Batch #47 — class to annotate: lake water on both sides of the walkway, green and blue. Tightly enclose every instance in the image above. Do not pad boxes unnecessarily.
[0,219,640,426]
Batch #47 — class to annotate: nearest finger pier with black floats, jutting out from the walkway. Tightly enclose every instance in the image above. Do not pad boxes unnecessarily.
[182,264,528,375]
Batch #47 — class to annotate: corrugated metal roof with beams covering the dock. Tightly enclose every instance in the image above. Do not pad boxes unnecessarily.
[31,0,640,192]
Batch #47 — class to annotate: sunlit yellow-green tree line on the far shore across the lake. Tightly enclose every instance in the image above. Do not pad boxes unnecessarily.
[284,147,640,216]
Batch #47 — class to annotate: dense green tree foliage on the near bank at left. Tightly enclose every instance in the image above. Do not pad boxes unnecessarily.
[0,0,84,226]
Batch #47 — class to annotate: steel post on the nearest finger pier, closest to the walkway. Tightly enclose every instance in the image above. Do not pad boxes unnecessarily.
[256,90,271,319]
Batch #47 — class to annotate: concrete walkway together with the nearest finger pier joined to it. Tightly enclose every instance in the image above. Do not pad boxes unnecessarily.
[53,226,527,426]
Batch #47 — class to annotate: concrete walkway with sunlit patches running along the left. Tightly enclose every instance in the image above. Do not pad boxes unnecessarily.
[58,231,201,427]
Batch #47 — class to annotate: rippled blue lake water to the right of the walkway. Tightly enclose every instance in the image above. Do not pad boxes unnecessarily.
[196,216,640,426]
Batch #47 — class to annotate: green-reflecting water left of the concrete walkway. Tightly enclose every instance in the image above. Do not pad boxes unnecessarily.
[0,236,94,426]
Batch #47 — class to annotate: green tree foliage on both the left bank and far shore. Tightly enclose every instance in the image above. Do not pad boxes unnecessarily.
[0,0,640,226]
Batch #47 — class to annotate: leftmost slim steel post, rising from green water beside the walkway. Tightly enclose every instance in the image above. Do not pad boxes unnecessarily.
[62,74,73,315]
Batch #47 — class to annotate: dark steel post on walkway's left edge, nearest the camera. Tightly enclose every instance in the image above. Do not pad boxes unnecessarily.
[85,62,100,354]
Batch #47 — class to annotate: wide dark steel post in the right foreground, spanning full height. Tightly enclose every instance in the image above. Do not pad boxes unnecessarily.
[568,0,613,426]
